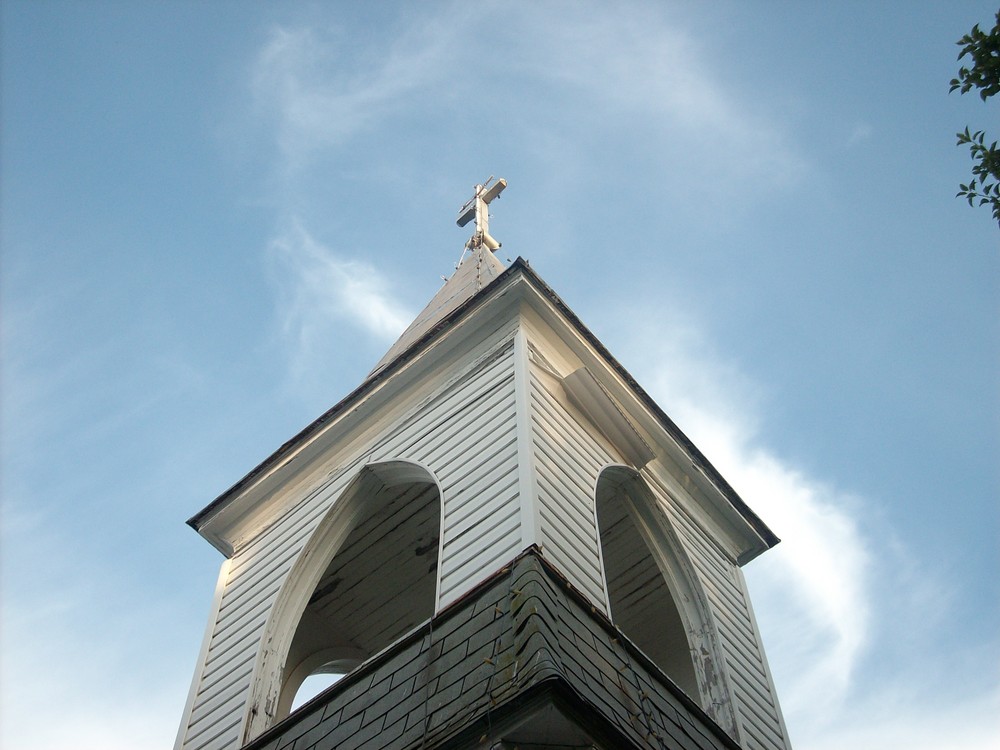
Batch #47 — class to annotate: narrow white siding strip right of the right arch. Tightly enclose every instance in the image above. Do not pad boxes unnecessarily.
[644,471,788,750]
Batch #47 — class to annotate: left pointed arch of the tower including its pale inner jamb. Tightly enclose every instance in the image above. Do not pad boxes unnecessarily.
[243,460,443,742]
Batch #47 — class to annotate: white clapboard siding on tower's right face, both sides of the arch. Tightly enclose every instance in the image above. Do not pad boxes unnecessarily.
[530,323,787,750]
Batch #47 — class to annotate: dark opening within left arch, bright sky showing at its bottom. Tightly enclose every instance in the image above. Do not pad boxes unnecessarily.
[275,470,441,719]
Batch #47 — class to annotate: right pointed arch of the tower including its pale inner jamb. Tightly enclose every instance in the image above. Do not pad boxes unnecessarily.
[595,465,737,736]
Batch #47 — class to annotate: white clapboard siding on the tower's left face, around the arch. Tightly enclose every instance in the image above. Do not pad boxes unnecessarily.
[181,336,521,750]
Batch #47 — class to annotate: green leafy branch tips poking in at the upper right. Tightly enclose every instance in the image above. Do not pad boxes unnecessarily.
[949,11,1000,223]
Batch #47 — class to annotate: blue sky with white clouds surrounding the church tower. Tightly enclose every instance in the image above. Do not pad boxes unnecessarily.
[0,0,1000,750]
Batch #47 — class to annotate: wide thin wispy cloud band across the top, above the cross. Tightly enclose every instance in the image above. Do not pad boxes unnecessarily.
[251,2,805,188]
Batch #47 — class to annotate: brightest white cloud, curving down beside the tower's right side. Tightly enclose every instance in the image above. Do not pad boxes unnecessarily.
[628,313,870,713]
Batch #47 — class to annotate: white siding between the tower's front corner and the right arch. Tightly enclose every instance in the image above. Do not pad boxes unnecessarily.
[530,365,621,612]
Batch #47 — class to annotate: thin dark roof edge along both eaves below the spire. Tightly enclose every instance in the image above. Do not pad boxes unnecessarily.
[187,256,781,547]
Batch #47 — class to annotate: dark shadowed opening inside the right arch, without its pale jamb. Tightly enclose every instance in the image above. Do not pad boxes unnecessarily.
[597,469,703,703]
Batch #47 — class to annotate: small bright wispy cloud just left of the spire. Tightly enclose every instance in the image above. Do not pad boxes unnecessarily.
[269,222,413,388]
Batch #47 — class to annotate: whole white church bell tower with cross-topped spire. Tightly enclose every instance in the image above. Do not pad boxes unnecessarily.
[175,178,789,750]
